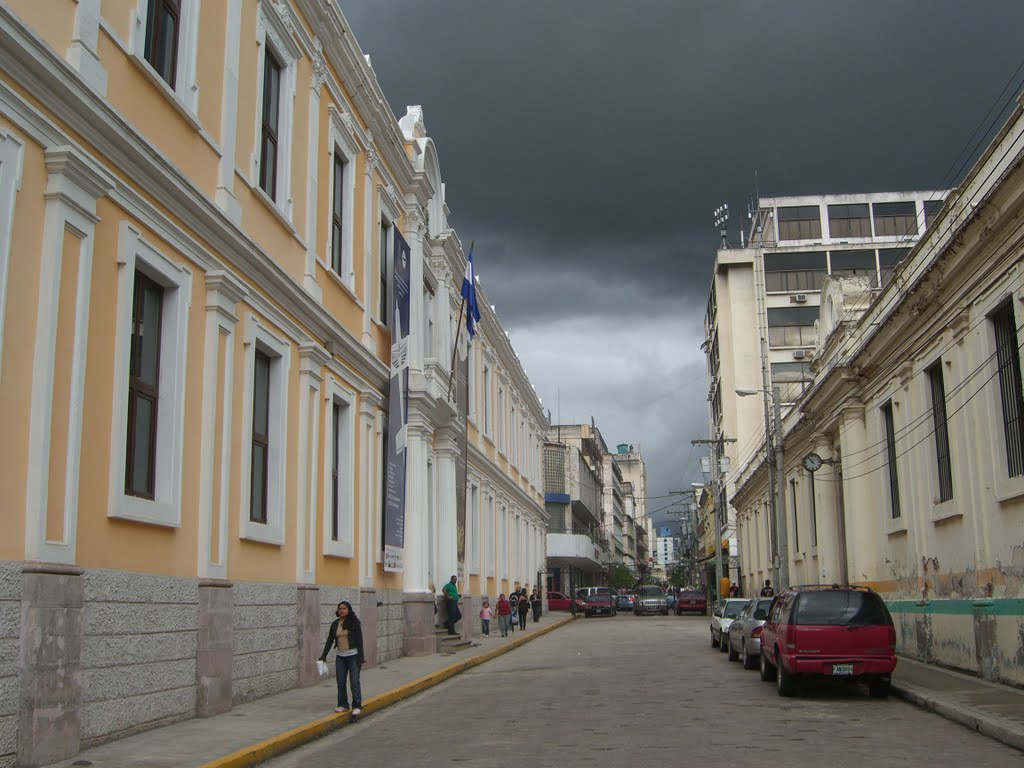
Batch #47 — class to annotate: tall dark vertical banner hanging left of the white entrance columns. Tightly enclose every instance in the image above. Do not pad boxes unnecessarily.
[384,227,411,572]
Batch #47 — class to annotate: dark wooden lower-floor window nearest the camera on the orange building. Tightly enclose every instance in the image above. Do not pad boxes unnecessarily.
[125,270,164,499]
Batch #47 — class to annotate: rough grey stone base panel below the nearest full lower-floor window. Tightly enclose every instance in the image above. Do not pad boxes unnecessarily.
[79,570,199,749]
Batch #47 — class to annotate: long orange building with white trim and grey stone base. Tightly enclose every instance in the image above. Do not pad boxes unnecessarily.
[0,0,547,765]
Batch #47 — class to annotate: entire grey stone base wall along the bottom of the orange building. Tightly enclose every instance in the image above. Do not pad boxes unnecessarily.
[0,561,460,768]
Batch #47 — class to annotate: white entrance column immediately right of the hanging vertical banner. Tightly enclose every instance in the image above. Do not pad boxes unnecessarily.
[402,417,432,593]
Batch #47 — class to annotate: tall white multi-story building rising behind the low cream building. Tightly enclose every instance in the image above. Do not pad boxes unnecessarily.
[703,191,945,583]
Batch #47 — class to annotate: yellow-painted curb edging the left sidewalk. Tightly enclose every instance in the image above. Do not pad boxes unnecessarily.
[200,616,573,768]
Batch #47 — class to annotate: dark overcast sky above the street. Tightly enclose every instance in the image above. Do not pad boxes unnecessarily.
[340,0,1024,532]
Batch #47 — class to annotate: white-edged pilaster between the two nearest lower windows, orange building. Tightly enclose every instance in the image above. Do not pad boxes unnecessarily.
[198,271,248,579]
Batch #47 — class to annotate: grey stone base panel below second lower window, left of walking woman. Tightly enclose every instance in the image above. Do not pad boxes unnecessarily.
[231,582,298,705]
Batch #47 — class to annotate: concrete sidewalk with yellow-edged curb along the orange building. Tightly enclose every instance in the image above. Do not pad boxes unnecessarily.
[49,612,572,768]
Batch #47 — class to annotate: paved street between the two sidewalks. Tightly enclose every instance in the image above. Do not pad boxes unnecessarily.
[268,614,1024,768]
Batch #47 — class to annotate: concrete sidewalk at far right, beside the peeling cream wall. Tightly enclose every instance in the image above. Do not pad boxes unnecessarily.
[893,656,1024,751]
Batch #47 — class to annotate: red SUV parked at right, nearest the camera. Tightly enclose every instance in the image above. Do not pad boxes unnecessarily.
[761,584,896,698]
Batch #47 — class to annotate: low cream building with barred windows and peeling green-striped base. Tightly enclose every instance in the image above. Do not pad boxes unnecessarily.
[733,97,1024,685]
